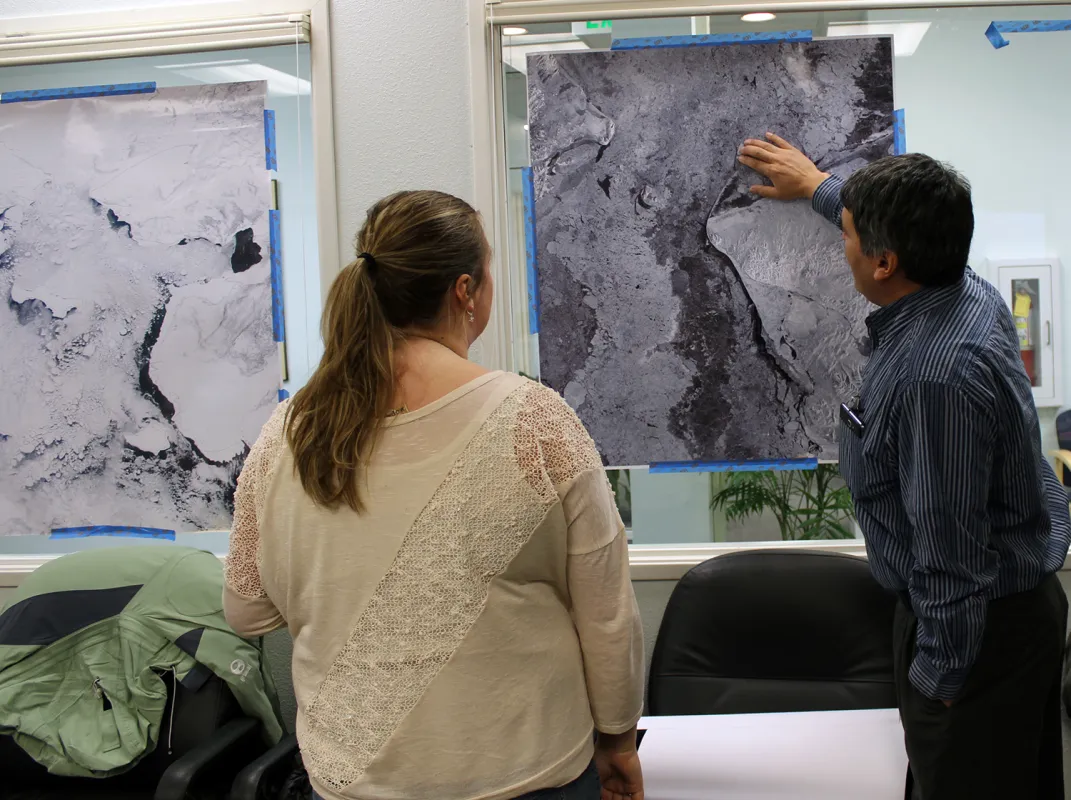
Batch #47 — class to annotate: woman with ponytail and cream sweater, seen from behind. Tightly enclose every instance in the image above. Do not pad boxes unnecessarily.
[224,192,644,800]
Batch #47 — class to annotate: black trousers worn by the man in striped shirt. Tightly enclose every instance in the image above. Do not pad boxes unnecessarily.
[893,576,1068,800]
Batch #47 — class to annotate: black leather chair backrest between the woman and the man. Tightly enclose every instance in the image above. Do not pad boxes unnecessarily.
[648,549,896,715]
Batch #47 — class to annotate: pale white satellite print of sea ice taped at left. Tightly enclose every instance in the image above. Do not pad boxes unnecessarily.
[0,82,281,534]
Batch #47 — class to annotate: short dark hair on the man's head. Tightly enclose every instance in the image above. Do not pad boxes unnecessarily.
[841,153,975,286]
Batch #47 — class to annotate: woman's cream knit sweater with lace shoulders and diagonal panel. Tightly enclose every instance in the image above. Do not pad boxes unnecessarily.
[224,373,644,800]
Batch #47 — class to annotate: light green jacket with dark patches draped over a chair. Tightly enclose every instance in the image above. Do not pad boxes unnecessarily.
[0,545,283,778]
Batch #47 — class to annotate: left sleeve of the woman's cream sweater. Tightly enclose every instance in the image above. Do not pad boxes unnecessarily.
[223,404,289,638]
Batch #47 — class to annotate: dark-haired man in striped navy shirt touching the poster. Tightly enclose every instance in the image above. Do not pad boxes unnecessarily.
[739,134,1071,800]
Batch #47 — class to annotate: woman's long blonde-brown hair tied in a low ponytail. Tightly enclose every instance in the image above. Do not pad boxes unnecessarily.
[286,192,488,512]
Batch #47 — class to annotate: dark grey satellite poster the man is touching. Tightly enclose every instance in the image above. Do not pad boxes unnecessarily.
[528,37,893,466]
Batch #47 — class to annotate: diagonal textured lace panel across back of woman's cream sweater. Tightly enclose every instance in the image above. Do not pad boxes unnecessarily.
[301,383,598,791]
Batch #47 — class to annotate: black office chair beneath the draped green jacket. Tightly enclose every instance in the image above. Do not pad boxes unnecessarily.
[0,659,265,800]
